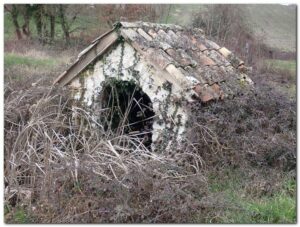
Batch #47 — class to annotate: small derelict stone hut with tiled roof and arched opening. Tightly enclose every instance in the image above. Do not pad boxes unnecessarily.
[54,22,252,150]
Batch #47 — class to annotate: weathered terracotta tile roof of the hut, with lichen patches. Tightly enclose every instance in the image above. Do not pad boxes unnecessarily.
[55,22,252,102]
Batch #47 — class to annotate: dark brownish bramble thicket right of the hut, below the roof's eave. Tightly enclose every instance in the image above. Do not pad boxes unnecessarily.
[186,84,296,171]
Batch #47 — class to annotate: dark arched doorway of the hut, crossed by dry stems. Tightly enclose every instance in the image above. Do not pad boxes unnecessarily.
[101,79,155,148]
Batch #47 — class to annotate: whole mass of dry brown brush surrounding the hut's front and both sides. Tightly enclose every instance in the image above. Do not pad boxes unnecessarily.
[4,75,296,223]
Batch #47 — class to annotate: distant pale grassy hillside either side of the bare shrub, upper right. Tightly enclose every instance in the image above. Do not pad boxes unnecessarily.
[167,4,296,51]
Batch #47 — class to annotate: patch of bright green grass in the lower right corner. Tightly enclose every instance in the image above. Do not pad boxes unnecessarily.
[206,169,296,224]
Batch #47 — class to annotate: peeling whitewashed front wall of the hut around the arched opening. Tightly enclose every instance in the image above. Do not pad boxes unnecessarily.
[70,42,187,150]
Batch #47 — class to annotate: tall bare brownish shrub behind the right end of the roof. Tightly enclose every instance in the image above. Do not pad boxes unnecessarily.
[192,4,270,64]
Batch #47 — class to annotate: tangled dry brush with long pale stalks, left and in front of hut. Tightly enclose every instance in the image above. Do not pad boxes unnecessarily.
[4,79,206,223]
